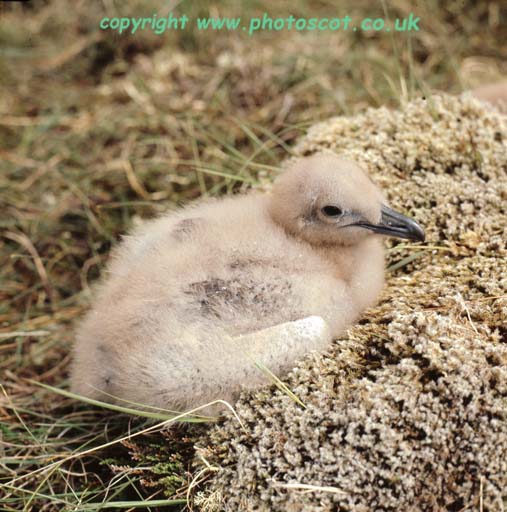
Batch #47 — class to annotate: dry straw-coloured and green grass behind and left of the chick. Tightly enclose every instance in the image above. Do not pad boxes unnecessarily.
[0,0,507,511]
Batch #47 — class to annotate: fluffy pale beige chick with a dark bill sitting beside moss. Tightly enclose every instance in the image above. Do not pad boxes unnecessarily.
[72,154,424,410]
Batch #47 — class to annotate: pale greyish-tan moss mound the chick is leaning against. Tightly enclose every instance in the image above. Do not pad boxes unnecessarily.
[200,96,507,512]
